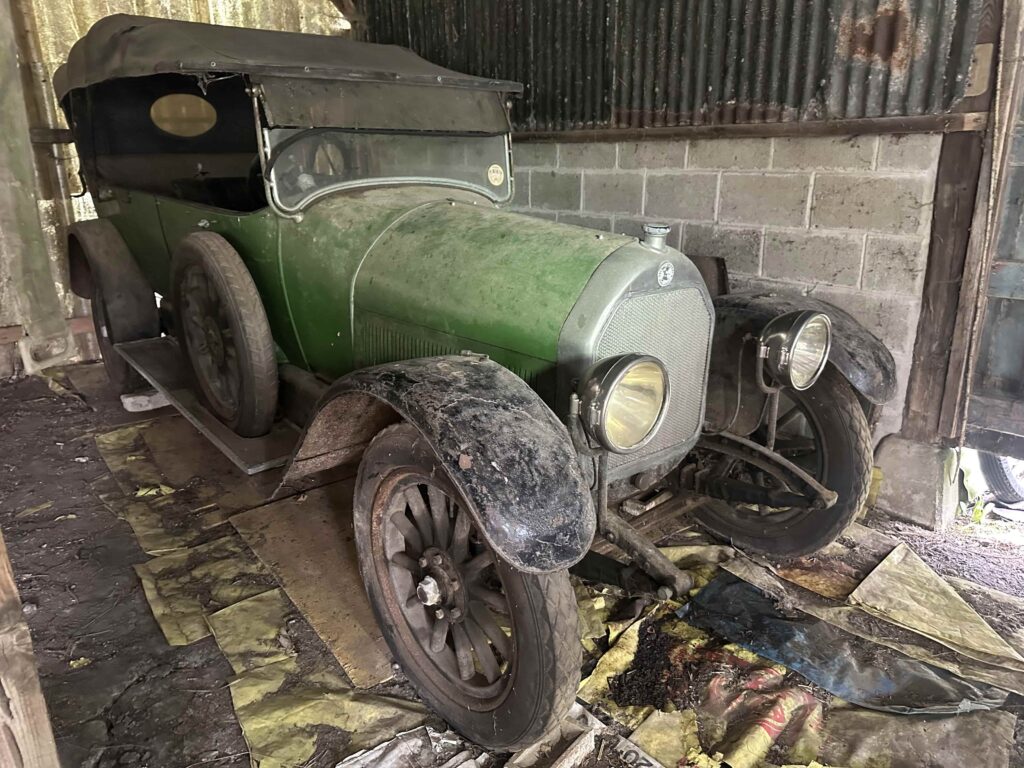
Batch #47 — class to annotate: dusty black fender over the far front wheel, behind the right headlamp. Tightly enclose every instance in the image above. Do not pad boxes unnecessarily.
[715,292,896,406]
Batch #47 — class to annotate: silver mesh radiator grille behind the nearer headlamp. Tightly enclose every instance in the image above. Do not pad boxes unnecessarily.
[597,288,712,469]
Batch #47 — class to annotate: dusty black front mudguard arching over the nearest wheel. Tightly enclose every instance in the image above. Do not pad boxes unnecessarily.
[282,355,597,573]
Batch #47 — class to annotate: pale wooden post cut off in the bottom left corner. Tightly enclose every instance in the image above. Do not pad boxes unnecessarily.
[0,534,60,768]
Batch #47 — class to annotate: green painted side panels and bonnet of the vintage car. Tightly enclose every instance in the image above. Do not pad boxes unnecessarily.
[112,186,632,397]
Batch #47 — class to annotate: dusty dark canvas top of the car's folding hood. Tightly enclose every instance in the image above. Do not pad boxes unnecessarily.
[53,13,522,99]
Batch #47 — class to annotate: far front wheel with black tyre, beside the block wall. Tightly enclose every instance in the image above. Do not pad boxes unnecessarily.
[694,366,872,557]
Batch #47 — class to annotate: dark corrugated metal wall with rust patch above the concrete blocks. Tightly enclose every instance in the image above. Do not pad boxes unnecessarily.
[365,0,982,131]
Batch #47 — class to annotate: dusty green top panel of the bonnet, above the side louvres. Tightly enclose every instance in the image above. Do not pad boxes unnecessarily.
[355,202,632,364]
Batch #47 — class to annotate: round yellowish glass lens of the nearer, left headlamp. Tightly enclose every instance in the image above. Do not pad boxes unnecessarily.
[604,360,666,451]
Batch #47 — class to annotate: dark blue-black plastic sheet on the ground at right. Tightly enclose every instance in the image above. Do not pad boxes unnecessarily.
[680,573,1007,715]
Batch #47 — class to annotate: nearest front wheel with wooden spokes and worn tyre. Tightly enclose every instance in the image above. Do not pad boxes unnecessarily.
[354,424,581,751]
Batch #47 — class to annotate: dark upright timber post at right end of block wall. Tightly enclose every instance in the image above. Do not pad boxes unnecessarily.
[902,133,984,443]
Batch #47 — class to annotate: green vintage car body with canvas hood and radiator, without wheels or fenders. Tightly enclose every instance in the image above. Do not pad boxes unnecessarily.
[54,16,715,564]
